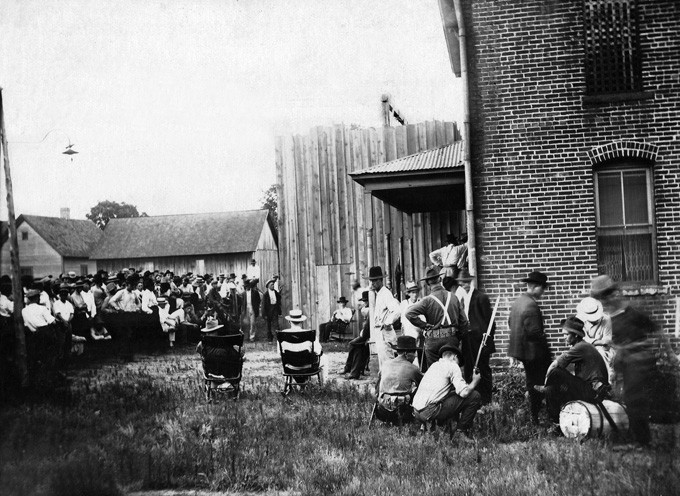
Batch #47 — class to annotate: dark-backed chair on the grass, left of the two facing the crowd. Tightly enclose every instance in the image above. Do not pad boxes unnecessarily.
[201,333,243,402]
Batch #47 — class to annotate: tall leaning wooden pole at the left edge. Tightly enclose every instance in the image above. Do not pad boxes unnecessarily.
[0,88,28,389]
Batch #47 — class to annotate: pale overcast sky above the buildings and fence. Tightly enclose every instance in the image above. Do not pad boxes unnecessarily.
[0,0,460,219]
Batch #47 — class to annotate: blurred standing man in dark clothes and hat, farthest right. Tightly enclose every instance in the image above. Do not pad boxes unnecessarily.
[590,275,666,446]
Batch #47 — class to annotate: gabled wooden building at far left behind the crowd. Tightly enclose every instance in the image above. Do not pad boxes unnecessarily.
[0,215,103,277]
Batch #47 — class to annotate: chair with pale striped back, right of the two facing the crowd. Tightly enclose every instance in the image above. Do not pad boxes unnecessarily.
[276,330,323,396]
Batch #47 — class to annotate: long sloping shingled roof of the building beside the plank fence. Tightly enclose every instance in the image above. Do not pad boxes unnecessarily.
[90,210,268,260]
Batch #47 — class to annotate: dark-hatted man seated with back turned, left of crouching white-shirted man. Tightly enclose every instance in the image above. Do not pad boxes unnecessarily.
[375,336,423,424]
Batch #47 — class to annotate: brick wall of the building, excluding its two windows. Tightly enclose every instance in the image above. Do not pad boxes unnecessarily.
[463,0,680,356]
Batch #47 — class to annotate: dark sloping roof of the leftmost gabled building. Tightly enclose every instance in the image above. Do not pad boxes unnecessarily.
[17,215,103,258]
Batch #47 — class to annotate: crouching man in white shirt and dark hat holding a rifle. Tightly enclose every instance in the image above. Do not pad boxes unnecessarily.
[413,344,482,443]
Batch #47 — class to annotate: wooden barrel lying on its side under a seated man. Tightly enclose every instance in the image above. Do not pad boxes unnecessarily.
[560,400,628,438]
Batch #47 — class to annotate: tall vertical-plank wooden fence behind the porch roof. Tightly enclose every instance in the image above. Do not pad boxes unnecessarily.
[276,121,465,333]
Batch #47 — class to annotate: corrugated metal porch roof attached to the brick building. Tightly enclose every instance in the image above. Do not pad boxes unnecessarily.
[350,141,464,176]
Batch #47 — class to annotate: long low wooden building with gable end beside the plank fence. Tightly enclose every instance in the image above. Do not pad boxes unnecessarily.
[91,210,279,286]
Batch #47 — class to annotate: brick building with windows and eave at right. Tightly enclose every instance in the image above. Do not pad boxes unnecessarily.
[440,0,680,352]
